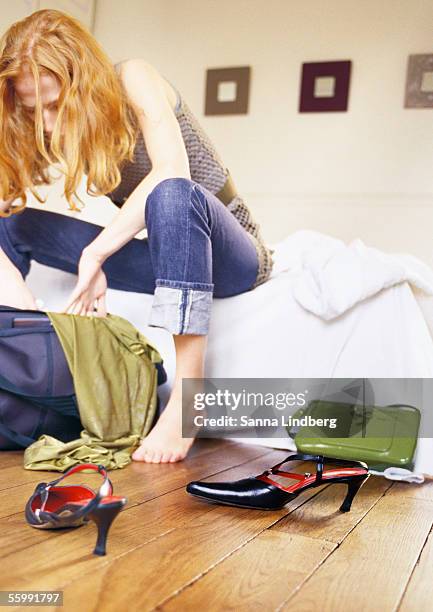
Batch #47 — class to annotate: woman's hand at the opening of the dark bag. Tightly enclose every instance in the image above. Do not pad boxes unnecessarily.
[63,249,107,317]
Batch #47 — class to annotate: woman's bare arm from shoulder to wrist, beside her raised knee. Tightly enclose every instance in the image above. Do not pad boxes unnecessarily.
[85,59,190,263]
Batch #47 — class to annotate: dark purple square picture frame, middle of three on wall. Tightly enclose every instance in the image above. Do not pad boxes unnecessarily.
[299,60,352,113]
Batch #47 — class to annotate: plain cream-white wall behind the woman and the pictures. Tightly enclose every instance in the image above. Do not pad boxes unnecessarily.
[0,0,433,265]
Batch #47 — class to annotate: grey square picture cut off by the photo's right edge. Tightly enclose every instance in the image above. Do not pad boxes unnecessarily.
[404,53,433,108]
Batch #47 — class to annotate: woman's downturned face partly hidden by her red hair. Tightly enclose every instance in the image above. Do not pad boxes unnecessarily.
[15,71,60,135]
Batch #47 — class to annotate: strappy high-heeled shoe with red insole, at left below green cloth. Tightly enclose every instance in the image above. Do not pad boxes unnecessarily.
[25,463,127,555]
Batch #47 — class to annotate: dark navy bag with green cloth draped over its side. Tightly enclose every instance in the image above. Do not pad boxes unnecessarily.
[0,306,83,450]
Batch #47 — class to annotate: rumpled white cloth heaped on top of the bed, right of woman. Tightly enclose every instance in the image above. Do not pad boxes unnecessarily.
[279,231,433,321]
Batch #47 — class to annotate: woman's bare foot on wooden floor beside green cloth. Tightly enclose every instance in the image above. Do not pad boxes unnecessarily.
[132,400,194,463]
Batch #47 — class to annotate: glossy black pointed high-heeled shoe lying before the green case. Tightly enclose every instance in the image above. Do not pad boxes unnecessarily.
[186,453,370,512]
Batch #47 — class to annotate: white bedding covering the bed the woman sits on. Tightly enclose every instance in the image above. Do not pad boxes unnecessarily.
[28,231,433,479]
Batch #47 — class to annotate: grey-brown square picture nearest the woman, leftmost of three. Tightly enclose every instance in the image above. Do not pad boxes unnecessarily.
[204,66,251,115]
